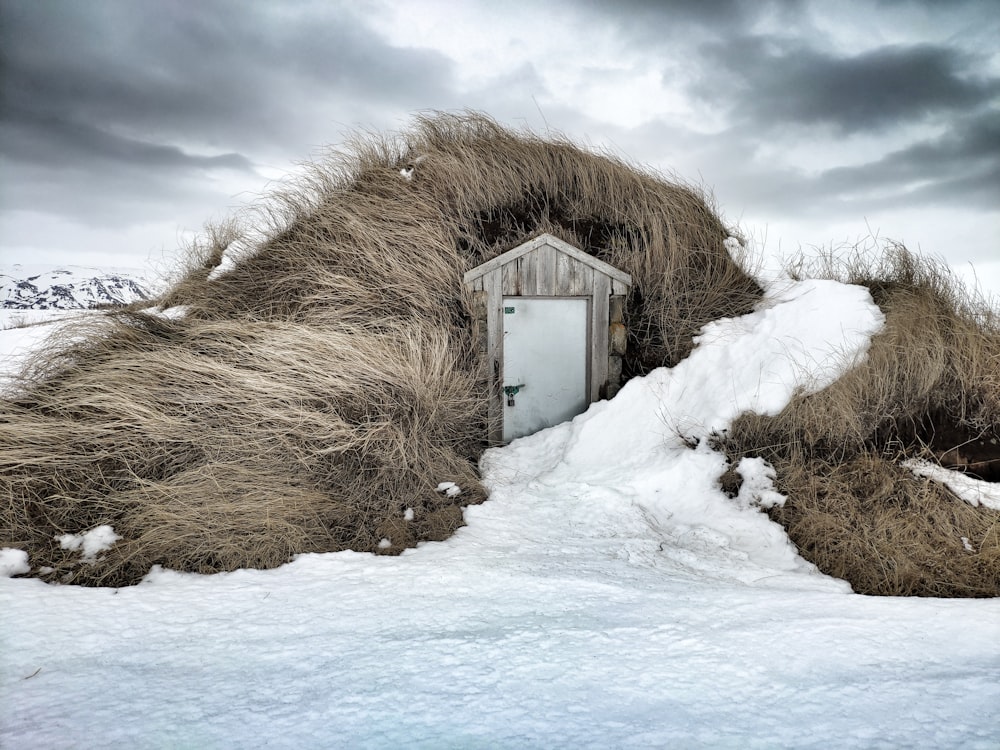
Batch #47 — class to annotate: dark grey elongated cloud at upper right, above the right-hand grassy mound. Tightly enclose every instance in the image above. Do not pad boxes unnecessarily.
[696,37,1000,133]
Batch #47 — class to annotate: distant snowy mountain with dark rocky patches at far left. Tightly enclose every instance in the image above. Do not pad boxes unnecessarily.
[0,264,156,310]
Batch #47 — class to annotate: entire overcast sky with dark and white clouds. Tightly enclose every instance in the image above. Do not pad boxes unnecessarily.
[0,0,1000,291]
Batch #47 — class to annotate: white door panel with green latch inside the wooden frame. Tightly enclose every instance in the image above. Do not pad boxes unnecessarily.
[501,297,590,442]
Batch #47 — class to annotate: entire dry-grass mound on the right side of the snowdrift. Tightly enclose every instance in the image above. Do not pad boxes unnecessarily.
[720,243,1000,596]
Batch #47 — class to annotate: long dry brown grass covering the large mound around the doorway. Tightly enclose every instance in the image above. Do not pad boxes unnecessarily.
[0,114,760,585]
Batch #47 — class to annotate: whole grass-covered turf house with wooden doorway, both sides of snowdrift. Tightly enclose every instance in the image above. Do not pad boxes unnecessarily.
[0,114,1000,596]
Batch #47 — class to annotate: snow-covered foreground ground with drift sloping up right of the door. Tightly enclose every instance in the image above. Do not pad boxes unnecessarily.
[0,282,1000,749]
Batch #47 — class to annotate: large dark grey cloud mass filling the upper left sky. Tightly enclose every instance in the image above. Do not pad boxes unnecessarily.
[0,0,451,163]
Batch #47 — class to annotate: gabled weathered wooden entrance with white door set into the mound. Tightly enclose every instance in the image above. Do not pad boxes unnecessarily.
[464,234,632,443]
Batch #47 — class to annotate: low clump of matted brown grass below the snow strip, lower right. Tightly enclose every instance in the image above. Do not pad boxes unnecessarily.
[769,452,1000,597]
